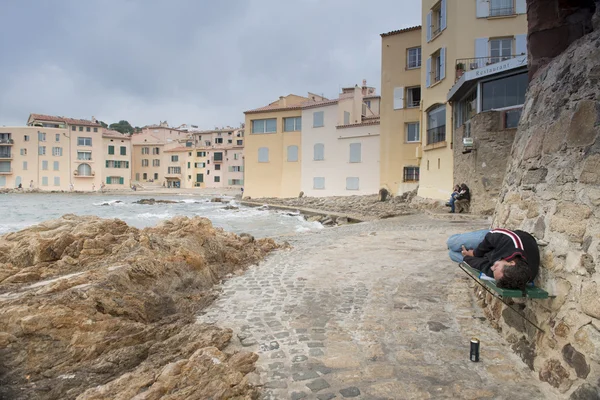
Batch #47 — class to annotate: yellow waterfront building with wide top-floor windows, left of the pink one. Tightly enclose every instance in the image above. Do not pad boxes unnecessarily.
[244,93,324,197]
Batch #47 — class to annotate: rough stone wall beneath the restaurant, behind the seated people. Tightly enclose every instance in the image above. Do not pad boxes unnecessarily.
[453,111,516,215]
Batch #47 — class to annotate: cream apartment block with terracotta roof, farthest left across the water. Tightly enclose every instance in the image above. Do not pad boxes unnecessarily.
[0,114,103,191]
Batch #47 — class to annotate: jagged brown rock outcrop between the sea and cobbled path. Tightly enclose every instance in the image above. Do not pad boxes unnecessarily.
[0,215,276,399]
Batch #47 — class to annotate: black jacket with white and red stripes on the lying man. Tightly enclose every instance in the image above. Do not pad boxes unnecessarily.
[464,229,540,281]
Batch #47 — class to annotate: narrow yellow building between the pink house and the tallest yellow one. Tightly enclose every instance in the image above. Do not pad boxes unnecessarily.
[380,26,421,194]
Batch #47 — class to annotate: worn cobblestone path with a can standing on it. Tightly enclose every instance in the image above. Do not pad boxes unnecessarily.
[198,215,556,400]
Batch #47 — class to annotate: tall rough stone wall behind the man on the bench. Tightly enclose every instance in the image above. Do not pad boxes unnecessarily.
[483,10,600,399]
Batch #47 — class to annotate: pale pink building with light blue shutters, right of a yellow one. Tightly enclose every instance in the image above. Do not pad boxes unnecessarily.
[300,81,380,197]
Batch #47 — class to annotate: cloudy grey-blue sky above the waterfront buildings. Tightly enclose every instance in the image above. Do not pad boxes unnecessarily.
[0,0,421,129]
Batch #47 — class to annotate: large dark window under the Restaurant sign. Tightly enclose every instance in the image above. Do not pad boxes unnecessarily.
[481,73,528,111]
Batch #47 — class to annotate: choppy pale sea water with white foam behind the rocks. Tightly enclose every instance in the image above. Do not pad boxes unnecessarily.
[0,193,323,238]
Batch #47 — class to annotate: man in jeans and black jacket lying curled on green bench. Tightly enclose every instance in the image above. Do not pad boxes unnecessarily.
[447,229,540,290]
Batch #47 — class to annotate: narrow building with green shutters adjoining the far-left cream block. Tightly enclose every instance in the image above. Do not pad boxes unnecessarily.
[102,129,132,190]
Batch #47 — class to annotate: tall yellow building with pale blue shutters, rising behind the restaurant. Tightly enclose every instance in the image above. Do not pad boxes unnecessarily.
[418,0,527,199]
